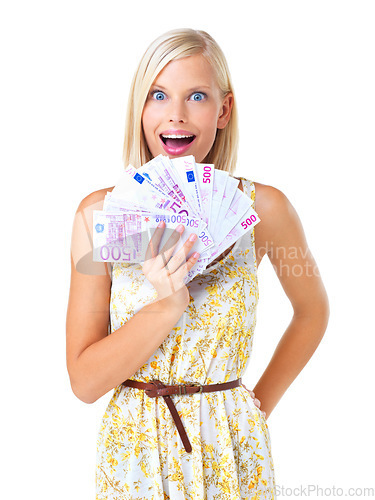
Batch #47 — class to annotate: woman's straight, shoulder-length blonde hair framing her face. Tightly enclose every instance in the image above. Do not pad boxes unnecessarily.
[123,28,238,173]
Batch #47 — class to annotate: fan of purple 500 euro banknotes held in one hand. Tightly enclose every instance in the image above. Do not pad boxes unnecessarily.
[93,155,260,284]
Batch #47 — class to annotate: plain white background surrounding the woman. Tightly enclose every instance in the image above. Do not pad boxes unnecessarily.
[0,0,375,500]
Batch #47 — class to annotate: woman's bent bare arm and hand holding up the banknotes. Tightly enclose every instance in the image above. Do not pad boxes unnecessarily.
[66,190,200,403]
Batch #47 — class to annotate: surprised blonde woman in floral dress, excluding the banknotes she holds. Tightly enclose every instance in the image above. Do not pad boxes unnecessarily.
[67,29,329,500]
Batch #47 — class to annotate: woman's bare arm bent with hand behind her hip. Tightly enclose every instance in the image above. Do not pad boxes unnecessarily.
[253,184,329,416]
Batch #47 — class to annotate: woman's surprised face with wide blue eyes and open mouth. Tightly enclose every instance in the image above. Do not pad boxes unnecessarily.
[142,54,233,163]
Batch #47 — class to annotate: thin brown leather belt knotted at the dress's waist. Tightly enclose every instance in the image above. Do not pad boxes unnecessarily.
[122,378,242,453]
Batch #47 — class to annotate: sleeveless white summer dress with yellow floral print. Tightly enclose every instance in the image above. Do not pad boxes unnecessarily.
[96,177,275,500]
